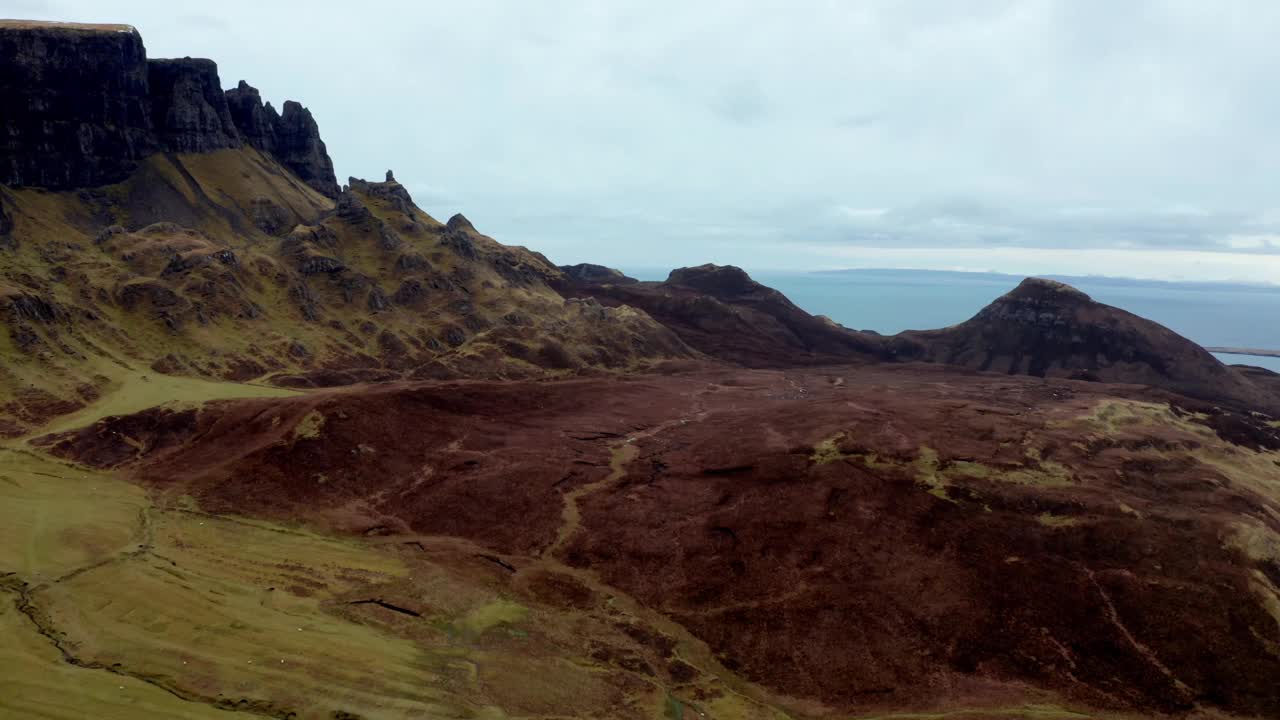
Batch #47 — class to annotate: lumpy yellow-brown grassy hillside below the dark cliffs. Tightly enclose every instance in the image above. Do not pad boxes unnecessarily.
[0,150,686,434]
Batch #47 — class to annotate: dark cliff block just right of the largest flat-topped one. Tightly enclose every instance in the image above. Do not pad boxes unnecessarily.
[147,58,241,152]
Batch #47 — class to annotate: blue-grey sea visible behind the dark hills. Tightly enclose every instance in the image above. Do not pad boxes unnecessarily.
[628,270,1280,373]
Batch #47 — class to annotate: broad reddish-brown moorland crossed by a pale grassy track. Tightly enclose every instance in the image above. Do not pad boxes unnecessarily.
[42,364,1280,716]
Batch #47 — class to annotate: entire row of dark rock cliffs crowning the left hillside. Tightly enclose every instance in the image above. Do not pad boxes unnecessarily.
[0,20,338,199]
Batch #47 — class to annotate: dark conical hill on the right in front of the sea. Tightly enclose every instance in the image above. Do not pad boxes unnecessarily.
[892,278,1275,406]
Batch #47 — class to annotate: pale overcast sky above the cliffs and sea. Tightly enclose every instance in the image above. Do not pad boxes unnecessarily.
[0,0,1280,283]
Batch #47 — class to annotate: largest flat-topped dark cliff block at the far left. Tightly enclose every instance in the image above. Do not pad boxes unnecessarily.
[0,20,156,188]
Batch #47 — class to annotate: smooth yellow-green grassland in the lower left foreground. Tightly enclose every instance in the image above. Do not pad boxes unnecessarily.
[0,378,781,719]
